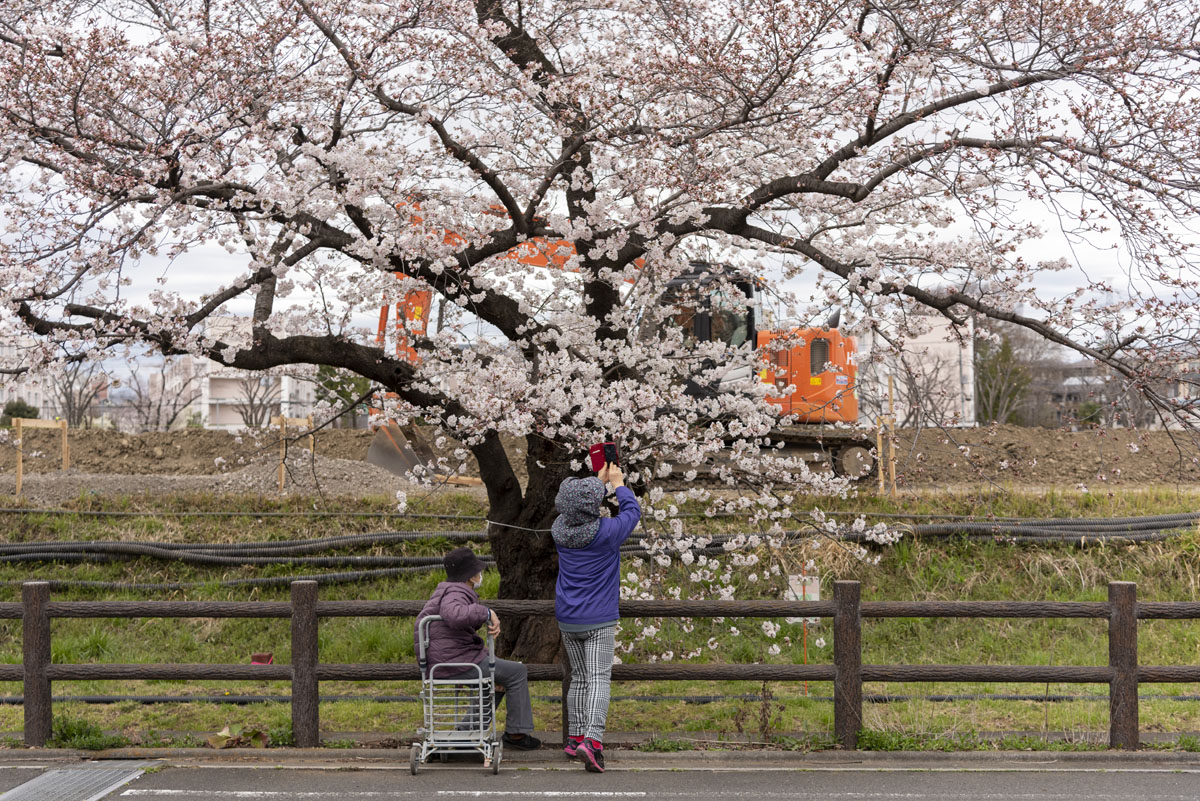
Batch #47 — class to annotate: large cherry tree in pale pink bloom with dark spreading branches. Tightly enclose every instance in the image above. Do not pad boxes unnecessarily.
[0,0,1200,656]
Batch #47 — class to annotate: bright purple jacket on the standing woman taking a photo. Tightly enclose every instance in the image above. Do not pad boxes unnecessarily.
[554,487,642,625]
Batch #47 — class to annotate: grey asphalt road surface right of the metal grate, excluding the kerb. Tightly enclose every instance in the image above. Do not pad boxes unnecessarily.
[100,767,1200,801]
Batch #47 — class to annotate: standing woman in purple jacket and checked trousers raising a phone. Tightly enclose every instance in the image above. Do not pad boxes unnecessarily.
[551,463,642,773]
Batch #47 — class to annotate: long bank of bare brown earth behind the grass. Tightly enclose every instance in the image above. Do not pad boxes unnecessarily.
[0,426,1200,504]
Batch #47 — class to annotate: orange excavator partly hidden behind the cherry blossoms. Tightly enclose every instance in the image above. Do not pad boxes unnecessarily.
[367,233,876,478]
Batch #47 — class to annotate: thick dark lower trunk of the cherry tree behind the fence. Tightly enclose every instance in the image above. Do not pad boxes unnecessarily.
[476,438,570,663]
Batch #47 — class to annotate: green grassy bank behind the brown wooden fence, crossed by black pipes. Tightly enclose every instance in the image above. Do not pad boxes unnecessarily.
[0,488,1200,749]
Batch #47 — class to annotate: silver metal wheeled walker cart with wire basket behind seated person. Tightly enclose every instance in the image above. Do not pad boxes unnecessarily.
[409,615,504,776]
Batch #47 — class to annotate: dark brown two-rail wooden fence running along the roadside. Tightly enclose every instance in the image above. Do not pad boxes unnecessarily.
[7,582,1200,749]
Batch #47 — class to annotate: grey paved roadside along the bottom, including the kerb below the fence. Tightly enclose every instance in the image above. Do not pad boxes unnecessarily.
[0,751,1200,801]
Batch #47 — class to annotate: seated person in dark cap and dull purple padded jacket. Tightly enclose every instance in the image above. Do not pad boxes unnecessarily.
[413,548,541,751]
